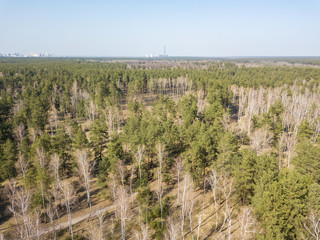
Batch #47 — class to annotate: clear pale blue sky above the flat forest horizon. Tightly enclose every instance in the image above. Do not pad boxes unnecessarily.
[0,0,320,57]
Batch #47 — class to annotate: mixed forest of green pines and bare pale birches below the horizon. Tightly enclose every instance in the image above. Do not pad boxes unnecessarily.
[0,58,320,240]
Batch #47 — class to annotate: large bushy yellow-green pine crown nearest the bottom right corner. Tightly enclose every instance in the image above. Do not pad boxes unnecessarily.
[253,169,312,239]
